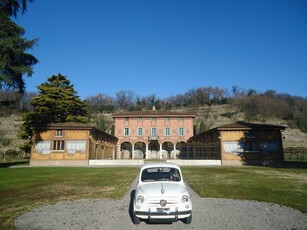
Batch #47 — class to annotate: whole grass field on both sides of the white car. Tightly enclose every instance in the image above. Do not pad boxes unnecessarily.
[0,166,307,229]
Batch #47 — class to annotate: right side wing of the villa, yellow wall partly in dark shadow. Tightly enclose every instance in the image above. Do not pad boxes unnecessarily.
[188,122,286,165]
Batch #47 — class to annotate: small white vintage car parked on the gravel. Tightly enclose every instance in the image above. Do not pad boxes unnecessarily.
[133,163,192,224]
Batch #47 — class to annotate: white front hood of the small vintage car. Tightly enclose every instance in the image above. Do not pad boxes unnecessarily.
[138,182,187,196]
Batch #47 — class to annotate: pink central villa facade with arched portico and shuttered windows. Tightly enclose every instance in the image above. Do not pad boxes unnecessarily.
[113,110,195,159]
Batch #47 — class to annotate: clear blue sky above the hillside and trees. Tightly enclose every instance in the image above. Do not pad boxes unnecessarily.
[16,0,307,99]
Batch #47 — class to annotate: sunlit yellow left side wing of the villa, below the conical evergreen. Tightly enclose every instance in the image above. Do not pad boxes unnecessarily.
[30,123,117,166]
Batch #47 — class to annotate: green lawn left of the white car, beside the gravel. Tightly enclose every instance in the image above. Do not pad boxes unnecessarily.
[0,168,139,229]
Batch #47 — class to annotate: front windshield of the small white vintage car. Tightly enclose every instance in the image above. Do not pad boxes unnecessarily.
[141,167,181,182]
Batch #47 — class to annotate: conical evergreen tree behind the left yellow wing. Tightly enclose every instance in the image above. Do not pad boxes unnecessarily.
[21,74,88,138]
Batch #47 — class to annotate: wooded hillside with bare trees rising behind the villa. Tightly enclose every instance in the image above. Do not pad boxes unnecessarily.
[0,87,307,162]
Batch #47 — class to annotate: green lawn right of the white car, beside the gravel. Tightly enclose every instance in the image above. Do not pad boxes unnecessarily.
[183,166,307,212]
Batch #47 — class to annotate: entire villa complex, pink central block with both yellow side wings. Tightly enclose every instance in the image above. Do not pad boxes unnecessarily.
[30,113,285,166]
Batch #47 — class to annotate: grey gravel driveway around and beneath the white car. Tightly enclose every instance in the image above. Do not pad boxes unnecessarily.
[15,180,307,230]
